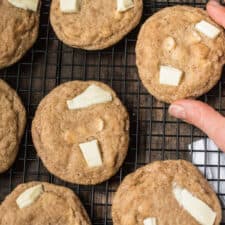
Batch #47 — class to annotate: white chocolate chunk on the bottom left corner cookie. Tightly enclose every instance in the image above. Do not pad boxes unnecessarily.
[16,184,44,209]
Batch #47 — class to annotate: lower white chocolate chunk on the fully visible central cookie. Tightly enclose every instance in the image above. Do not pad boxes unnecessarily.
[79,140,102,167]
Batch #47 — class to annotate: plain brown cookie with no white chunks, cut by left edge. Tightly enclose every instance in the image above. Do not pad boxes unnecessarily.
[0,79,26,173]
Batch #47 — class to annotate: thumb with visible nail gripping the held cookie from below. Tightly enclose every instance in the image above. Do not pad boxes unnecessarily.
[169,100,225,151]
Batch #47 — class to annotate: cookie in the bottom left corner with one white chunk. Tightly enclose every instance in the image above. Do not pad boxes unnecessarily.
[0,182,91,225]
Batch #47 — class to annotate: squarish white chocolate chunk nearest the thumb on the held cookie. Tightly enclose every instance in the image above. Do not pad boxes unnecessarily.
[159,66,183,86]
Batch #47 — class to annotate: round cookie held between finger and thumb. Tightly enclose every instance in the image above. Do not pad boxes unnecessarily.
[136,6,225,103]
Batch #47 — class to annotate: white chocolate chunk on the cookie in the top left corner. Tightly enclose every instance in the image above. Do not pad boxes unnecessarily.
[8,0,39,12]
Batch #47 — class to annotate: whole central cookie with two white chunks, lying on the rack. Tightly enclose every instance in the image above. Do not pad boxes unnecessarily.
[32,81,129,184]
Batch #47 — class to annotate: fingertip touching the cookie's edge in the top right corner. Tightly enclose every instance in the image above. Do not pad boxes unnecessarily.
[206,0,225,27]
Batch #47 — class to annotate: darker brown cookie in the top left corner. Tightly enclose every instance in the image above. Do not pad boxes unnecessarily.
[0,0,39,69]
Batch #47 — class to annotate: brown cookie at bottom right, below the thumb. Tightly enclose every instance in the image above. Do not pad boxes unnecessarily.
[112,160,222,225]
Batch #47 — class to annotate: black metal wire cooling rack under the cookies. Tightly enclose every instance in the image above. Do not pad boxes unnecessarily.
[0,0,225,225]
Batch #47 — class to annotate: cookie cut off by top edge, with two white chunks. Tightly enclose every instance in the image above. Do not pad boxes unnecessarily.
[50,0,143,50]
